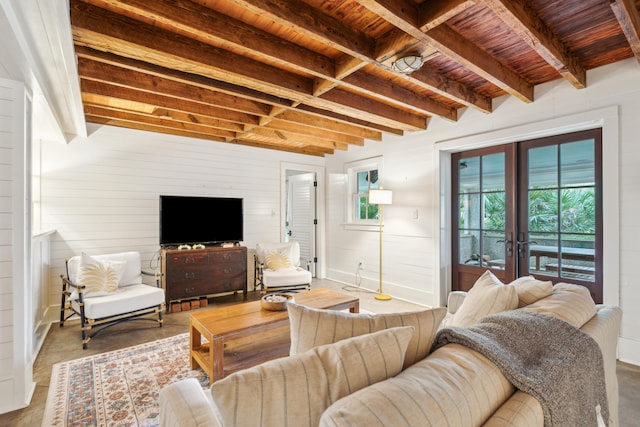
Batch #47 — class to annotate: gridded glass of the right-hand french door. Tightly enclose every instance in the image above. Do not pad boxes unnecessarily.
[518,130,601,295]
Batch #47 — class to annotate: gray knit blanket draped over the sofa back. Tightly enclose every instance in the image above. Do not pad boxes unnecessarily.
[433,310,609,427]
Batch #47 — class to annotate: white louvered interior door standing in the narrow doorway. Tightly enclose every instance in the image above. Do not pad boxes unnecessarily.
[285,173,316,277]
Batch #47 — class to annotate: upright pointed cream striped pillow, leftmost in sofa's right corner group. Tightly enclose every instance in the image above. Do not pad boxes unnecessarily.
[448,270,518,327]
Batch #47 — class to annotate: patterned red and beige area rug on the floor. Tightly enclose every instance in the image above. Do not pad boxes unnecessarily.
[42,333,209,427]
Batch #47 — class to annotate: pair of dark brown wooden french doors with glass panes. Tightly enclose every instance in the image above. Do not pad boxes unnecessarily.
[452,129,602,302]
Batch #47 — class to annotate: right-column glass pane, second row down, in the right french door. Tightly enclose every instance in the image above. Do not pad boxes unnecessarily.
[560,187,596,234]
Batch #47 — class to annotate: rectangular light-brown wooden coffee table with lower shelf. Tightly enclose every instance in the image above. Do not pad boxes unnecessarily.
[189,289,360,382]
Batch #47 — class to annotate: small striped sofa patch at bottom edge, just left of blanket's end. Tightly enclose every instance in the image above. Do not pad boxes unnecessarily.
[483,390,544,427]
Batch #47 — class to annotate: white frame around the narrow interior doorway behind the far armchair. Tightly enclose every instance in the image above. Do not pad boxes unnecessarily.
[279,162,327,279]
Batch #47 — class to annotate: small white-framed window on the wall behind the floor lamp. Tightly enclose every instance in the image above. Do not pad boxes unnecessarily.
[347,157,382,225]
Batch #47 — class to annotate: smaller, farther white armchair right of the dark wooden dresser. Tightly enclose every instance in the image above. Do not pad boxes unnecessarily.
[255,242,311,293]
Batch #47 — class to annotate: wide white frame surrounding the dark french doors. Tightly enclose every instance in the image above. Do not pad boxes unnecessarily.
[433,106,620,306]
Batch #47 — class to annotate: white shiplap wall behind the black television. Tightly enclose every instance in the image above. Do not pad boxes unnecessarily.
[41,125,324,318]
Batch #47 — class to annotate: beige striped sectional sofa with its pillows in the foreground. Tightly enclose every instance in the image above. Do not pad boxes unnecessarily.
[160,272,622,427]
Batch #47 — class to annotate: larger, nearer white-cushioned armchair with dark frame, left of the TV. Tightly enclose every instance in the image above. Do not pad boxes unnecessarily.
[60,252,164,349]
